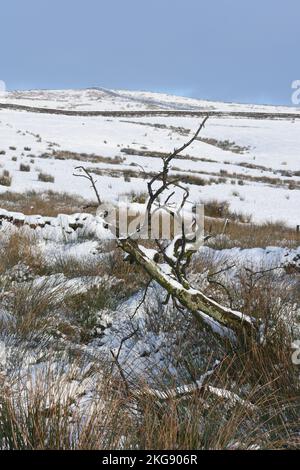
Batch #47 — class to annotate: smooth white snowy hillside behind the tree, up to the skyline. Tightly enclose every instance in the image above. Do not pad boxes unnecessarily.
[0,89,300,227]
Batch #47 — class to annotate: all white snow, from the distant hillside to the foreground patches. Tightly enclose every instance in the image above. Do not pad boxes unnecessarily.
[0,89,300,450]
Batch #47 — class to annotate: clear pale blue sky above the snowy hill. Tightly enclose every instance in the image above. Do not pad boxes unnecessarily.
[0,0,300,104]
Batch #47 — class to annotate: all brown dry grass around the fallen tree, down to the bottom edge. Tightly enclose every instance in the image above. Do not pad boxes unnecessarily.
[0,193,300,450]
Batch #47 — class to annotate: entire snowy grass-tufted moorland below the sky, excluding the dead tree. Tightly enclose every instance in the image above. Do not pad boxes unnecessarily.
[0,89,300,449]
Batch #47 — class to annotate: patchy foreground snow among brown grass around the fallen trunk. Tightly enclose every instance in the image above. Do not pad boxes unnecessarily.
[0,206,300,446]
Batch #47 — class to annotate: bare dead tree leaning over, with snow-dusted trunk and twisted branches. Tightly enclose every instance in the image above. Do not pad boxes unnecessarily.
[77,116,257,338]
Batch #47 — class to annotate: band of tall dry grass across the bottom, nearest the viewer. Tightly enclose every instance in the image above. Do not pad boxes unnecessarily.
[0,336,300,450]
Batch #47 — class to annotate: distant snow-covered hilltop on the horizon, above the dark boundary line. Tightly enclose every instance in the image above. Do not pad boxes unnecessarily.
[0,87,300,115]
